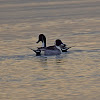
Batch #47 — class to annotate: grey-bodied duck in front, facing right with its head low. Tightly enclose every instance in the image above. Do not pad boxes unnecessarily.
[32,39,62,56]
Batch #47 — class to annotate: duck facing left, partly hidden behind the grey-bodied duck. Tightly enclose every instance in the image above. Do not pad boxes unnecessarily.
[36,34,71,52]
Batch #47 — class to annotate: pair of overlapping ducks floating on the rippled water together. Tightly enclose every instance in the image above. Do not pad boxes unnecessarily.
[31,34,71,56]
